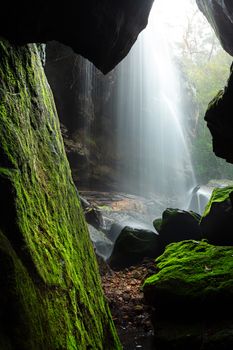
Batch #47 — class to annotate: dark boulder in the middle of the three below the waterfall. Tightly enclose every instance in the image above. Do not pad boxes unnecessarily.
[153,208,200,253]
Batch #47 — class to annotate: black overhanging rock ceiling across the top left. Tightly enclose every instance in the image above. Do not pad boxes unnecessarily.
[0,0,153,73]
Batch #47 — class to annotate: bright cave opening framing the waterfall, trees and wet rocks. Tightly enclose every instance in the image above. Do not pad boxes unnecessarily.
[45,0,233,349]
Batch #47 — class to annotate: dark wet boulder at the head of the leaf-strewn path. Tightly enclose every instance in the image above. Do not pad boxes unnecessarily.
[108,226,159,270]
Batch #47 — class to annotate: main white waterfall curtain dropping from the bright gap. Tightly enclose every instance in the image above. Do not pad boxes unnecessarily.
[114,1,195,209]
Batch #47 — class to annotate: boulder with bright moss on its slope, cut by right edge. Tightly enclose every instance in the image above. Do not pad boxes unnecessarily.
[200,186,233,245]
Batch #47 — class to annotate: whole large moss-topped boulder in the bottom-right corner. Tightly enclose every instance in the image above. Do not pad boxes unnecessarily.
[143,240,233,350]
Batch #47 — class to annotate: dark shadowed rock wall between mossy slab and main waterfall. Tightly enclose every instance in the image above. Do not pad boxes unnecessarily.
[45,41,117,190]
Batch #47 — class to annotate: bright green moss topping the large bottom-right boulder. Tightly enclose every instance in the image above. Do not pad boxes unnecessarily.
[143,241,233,302]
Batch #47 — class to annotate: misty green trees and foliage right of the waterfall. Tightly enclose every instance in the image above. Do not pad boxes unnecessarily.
[177,5,233,183]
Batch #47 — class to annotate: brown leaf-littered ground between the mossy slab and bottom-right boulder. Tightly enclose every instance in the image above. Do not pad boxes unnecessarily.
[101,260,155,350]
